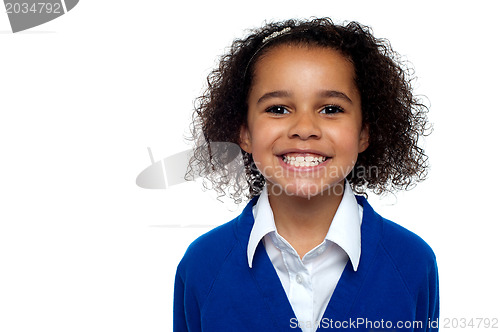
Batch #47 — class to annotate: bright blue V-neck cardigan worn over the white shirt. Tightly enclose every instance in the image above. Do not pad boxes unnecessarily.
[174,196,439,332]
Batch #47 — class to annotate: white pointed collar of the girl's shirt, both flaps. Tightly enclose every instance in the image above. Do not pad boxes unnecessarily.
[247,180,362,271]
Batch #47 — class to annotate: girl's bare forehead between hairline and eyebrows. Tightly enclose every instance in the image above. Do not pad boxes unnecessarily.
[251,44,357,93]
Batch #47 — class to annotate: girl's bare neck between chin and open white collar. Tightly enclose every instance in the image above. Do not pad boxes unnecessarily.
[268,181,344,258]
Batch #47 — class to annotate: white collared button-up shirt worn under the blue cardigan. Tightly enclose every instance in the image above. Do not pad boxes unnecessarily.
[247,180,363,332]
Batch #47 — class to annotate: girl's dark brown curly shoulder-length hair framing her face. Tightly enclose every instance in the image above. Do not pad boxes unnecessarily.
[186,18,430,203]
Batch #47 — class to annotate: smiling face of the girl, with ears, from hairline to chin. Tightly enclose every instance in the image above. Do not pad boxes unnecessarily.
[240,45,368,198]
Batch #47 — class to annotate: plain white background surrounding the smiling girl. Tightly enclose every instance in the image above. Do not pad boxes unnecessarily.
[0,0,500,332]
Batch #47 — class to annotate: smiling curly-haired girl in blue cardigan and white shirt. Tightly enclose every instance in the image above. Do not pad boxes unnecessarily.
[174,19,439,332]
